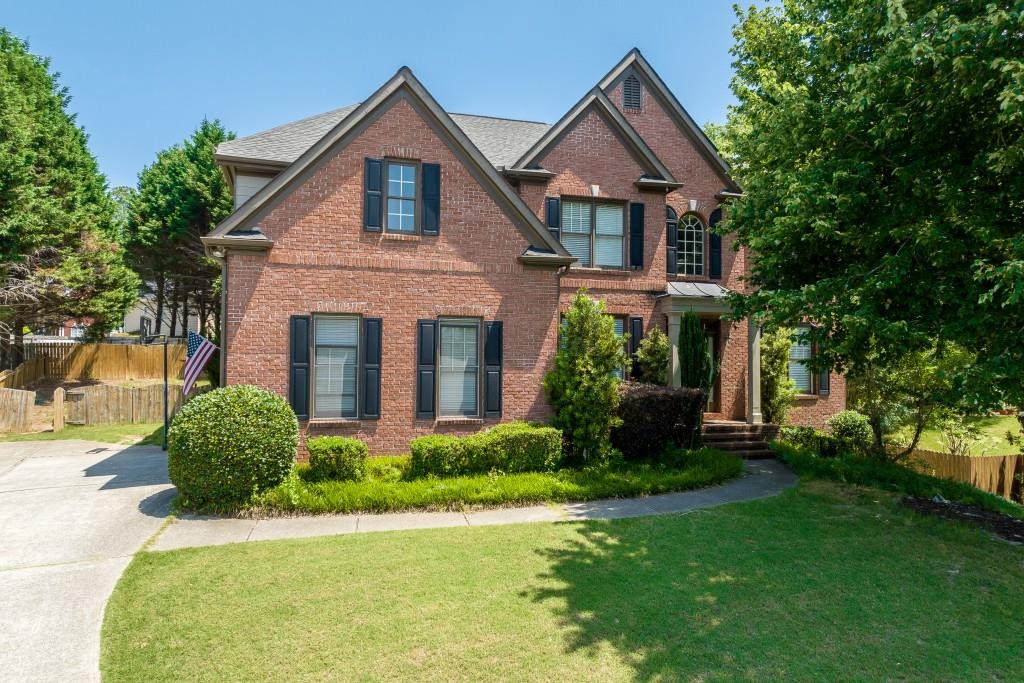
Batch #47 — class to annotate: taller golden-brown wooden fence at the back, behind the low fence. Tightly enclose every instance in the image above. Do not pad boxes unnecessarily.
[26,343,185,380]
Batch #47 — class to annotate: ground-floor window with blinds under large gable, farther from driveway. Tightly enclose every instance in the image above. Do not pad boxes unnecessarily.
[440,322,479,416]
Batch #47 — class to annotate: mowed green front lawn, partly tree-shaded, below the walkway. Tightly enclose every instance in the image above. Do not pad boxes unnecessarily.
[101,481,1024,683]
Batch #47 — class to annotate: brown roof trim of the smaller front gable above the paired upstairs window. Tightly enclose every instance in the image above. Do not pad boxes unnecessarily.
[512,88,679,185]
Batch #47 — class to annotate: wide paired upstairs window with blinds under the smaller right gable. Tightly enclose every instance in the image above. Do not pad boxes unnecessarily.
[561,200,626,268]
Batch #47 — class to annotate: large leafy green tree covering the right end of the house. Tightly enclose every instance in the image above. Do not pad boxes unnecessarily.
[715,0,1024,408]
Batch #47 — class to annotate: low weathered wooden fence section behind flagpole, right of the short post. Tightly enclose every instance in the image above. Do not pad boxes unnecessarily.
[63,384,207,426]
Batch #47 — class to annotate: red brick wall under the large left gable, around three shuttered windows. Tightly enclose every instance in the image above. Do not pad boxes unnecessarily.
[226,100,558,453]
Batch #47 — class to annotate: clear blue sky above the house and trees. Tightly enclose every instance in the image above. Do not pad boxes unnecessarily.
[0,0,749,186]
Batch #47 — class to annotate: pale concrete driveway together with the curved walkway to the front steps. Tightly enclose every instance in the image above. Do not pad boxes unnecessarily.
[0,440,797,683]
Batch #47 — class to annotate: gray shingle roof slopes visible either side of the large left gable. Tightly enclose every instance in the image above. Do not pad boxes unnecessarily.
[217,104,551,167]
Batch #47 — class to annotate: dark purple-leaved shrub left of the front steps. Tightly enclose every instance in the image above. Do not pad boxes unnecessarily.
[611,382,707,460]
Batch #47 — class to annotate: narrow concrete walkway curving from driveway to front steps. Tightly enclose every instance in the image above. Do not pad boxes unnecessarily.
[153,460,797,550]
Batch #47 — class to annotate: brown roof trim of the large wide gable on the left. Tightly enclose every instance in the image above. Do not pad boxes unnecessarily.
[203,67,574,264]
